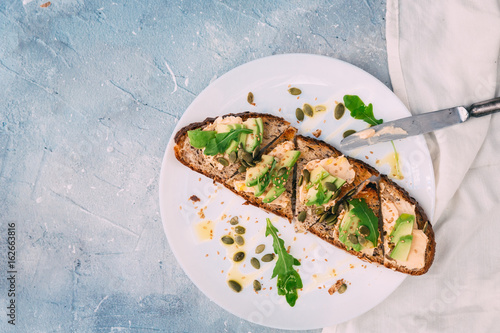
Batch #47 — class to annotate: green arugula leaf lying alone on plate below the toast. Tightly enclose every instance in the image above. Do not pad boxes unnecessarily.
[266,218,303,307]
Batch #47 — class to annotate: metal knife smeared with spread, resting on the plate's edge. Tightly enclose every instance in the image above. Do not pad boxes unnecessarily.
[340,97,500,150]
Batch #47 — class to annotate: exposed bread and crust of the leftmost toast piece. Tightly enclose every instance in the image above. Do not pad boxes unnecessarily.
[174,112,290,184]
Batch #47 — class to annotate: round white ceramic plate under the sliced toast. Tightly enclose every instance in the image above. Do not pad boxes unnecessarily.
[160,54,435,329]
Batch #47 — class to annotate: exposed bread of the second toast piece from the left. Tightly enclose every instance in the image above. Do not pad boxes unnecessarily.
[224,127,297,222]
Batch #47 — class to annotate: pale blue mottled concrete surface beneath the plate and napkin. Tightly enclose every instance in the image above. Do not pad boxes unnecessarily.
[0,0,390,332]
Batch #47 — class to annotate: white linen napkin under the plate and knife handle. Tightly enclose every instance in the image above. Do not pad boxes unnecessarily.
[323,0,500,333]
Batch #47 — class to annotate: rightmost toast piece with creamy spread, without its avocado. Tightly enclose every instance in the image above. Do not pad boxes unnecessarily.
[380,176,436,275]
